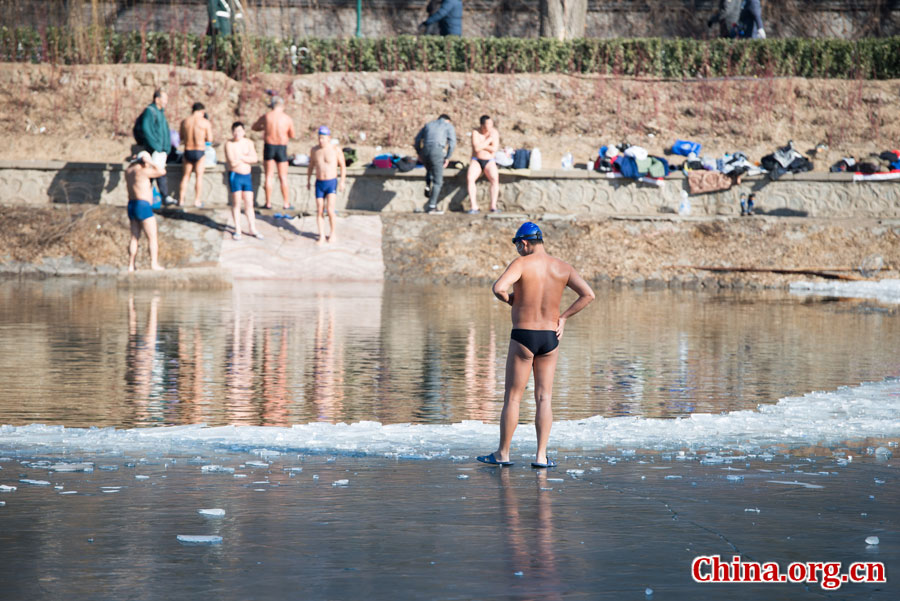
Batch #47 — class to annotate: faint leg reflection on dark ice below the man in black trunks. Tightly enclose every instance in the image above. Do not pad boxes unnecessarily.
[498,470,562,601]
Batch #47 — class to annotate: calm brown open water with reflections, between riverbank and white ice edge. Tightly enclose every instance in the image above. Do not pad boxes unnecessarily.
[0,280,900,427]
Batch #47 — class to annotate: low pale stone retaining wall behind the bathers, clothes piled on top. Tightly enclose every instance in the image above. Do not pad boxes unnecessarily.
[0,161,900,218]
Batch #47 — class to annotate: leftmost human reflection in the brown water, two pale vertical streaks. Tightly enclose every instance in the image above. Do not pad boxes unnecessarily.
[125,295,162,424]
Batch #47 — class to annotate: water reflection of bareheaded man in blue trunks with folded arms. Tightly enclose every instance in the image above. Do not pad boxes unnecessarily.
[225,309,259,426]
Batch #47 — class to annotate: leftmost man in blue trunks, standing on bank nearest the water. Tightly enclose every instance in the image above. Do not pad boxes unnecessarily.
[125,150,166,271]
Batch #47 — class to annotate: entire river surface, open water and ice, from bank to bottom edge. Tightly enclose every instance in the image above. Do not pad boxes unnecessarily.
[0,282,900,601]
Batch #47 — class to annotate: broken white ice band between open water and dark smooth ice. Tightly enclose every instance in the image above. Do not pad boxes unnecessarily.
[0,378,900,454]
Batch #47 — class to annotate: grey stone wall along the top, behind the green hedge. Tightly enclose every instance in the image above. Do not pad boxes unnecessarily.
[10,0,900,38]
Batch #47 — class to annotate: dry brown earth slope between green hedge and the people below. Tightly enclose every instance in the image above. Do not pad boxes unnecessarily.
[0,64,900,170]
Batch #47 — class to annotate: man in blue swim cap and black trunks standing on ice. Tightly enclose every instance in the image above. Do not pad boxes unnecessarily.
[477,221,594,468]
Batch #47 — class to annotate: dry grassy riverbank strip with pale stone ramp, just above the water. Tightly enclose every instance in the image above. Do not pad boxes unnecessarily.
[0,205,900,288]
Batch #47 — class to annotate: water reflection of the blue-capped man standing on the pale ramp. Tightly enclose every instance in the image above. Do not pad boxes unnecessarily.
[312,297,344,421]
